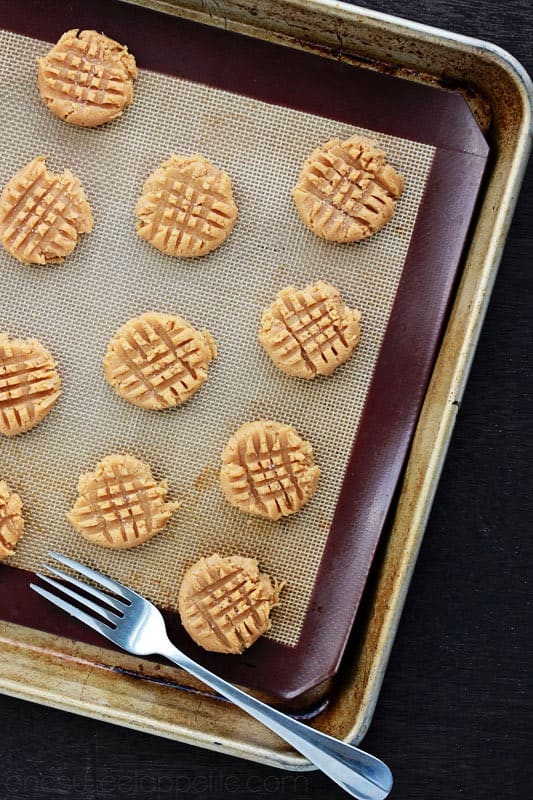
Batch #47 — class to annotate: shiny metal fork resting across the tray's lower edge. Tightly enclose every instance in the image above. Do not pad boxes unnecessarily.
[30,552,392,800]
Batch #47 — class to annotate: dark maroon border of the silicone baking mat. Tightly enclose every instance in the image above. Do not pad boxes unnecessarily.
[0,0,488,698]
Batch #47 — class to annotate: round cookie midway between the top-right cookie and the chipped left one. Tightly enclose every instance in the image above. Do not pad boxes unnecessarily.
[136,155,237,258]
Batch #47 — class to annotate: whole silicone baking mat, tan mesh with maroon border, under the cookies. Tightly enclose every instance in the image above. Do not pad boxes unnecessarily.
[0,4,486,696]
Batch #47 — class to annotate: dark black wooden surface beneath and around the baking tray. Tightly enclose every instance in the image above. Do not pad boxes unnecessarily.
[0,0,533,800]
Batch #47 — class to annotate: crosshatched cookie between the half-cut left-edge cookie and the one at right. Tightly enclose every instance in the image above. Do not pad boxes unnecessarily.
[104,312,217,409]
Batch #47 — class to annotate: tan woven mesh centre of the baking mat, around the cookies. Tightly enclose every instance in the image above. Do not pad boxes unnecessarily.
[0,32,434,646]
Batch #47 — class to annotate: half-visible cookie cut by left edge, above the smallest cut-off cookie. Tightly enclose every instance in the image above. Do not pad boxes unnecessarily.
[0,333,61,436]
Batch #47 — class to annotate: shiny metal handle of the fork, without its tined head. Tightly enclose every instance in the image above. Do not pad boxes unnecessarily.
[160,641,392,800]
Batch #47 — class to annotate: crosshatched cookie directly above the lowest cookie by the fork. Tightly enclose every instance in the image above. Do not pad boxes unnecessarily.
[220,419,320,520]
